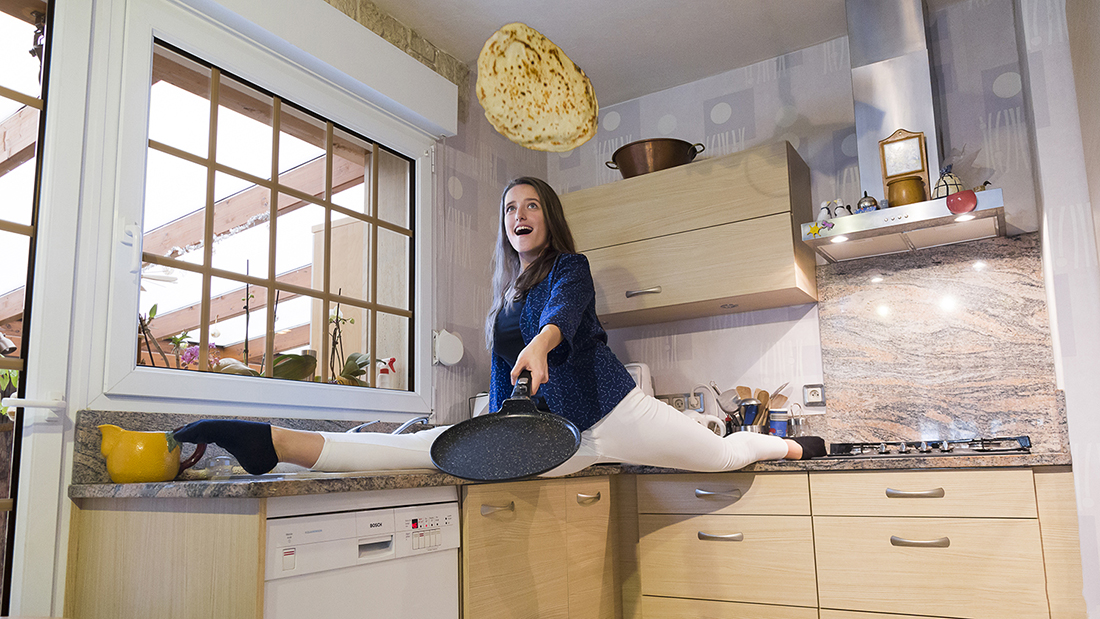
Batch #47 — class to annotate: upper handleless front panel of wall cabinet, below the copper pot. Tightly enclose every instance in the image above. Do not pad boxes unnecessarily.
[561,143,809,253]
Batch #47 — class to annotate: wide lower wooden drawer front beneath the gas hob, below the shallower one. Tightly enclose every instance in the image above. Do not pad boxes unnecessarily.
[814,516,1048,619]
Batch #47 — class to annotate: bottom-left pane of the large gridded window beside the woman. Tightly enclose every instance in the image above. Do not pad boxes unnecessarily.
[138,263,202,369]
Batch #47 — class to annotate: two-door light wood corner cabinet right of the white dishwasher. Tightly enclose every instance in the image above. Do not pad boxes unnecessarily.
[461,477,618,619]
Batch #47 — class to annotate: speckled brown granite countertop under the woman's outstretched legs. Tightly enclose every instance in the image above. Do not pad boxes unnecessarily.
[68,453,1070,499]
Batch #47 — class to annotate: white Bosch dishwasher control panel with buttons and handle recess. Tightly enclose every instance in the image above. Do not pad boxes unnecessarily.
[264,502,460,581]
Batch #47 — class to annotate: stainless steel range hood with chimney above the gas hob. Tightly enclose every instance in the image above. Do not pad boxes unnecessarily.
[802,0,1005,262]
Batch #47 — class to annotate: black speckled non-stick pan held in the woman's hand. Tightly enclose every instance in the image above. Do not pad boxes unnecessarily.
[431,371,581,482]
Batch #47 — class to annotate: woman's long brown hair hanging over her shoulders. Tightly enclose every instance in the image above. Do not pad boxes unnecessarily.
[485,176,576,352]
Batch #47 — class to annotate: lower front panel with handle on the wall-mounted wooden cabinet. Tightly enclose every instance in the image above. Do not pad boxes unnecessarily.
[585,213,795,318]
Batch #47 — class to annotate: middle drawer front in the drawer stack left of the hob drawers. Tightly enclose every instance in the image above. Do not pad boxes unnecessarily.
[638,515,817,617]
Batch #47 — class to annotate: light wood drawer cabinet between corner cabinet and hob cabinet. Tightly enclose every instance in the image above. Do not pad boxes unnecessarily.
[637,473,817,619]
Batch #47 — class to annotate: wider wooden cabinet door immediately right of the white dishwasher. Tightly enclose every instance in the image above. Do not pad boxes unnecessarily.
[462,479,569,619]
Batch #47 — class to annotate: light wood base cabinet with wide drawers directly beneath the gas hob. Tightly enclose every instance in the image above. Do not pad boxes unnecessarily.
[810,469,1049,619]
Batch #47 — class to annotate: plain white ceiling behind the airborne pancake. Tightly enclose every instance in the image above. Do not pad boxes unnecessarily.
[373,0,847,106]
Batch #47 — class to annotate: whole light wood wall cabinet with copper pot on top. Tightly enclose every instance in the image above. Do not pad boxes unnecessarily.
[561,142,817,329]
